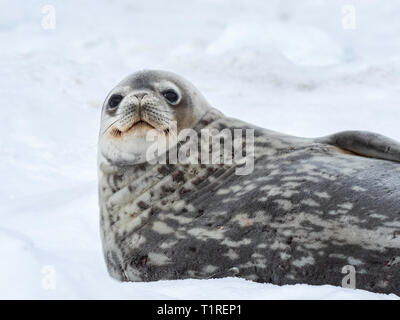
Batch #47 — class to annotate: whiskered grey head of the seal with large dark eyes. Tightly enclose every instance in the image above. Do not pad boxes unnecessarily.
[99,70,210,164]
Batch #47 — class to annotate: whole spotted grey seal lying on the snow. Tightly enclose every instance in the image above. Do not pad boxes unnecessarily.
[98,71,400,294]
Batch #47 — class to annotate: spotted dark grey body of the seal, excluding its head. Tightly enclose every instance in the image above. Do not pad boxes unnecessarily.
[99,70,400,294]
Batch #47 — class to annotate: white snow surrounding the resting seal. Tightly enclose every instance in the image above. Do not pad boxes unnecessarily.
[0,0,400,299]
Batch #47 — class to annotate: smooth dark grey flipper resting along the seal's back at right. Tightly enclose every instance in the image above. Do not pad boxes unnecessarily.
[315,131,400,162]
